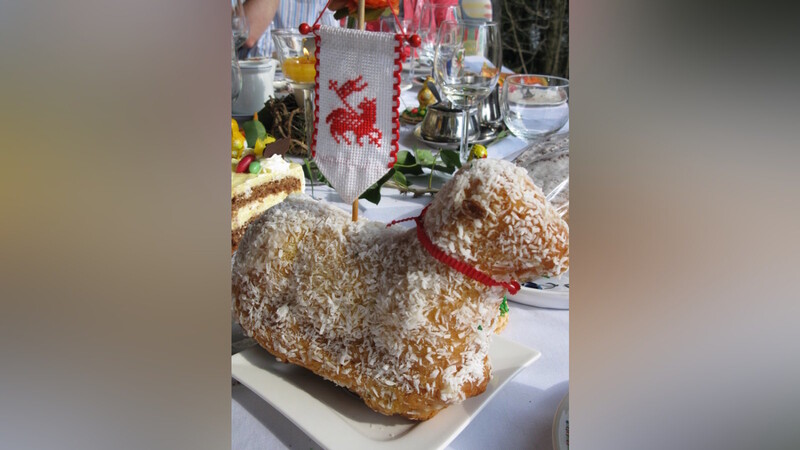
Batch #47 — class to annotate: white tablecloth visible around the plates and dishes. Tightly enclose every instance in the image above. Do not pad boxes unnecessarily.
[231,82,569,450]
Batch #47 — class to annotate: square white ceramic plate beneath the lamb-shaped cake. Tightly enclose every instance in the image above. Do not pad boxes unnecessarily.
[231,336,541,450]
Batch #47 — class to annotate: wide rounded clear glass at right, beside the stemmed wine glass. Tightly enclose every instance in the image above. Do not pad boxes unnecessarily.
[500,75,569,141]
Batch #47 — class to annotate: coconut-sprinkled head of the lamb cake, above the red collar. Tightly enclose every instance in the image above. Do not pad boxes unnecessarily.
[425,159,569,281]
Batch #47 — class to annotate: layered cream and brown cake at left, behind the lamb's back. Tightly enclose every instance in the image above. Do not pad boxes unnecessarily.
[231,155,305,253]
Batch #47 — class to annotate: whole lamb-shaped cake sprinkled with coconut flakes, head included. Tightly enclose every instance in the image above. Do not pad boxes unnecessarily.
[232,159,569,420]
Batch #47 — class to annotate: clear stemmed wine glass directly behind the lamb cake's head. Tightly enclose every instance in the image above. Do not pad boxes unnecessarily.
[433,21,503,162]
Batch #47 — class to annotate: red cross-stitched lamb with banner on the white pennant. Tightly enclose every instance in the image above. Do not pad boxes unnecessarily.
[325,75,383,147]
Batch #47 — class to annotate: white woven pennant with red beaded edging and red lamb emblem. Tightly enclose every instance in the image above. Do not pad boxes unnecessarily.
[312,26,401,203]
